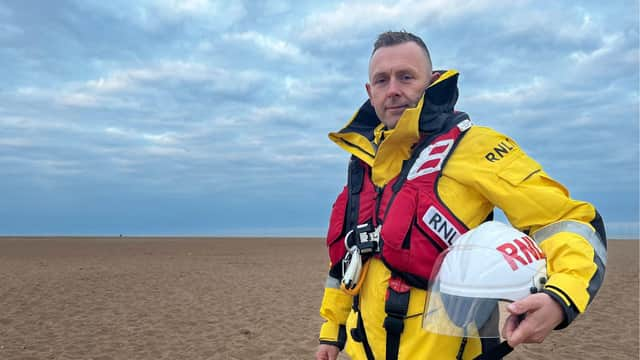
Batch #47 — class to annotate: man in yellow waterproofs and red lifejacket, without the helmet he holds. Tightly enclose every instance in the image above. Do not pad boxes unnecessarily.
[316,32,606,359]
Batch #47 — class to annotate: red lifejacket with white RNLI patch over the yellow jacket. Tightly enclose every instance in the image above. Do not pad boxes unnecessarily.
[327,113,471,289]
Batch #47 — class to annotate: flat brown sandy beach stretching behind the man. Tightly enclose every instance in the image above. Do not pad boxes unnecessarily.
[0,237,639,360]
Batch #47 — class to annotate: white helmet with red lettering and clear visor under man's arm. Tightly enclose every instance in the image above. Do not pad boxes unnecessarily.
[422,221,546,337]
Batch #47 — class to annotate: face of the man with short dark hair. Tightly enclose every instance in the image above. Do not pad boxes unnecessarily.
[366,42,432,129]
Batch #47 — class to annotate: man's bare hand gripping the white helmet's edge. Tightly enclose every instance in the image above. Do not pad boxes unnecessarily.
[502,293,564,348]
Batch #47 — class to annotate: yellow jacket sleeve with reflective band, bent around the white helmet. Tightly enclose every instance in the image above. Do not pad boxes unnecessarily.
[464,128,607,328]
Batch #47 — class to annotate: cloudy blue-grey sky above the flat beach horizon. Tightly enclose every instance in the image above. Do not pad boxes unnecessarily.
[0,0,640,238]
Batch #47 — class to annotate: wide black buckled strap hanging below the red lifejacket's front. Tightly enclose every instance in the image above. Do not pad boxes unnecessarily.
[384,286,409,360]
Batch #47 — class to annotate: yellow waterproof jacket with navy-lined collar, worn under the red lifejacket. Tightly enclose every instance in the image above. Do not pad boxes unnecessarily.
[320,71,606,359]
